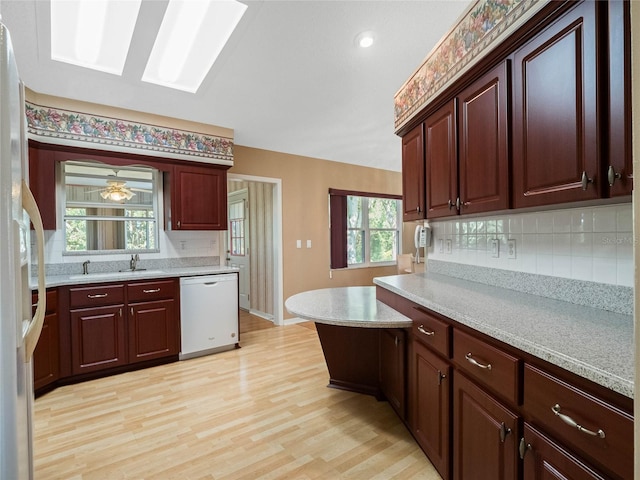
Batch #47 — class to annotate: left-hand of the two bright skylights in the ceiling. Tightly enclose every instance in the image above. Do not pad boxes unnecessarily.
[51,0,142,75]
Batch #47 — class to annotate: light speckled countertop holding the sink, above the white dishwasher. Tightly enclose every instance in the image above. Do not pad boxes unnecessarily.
[29,265,238,289]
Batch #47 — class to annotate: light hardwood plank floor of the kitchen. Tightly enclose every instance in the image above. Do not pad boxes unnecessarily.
[34,316,440,480]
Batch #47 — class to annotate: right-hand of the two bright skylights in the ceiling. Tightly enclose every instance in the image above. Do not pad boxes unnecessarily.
[142,0,247,93]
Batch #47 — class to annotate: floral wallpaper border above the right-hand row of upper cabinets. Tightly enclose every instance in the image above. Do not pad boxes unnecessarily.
[394,0,549,131]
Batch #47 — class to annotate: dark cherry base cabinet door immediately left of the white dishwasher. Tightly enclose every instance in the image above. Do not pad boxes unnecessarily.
[129,300,180,363]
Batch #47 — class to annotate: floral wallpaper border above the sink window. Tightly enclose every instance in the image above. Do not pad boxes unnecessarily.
[25,102,233,164]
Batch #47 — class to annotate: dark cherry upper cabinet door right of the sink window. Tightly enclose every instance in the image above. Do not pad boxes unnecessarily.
[171,166,227,230]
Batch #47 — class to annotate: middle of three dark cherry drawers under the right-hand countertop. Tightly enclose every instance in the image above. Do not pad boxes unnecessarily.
[453,329,521,405]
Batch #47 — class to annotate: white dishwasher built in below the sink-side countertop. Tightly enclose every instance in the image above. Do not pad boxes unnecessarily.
[180,273,239,360]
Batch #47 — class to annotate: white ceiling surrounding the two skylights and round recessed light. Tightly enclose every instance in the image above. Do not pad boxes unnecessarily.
[0,0,470,171]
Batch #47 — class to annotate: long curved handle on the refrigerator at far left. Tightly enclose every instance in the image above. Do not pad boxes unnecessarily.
[22,180,47,362]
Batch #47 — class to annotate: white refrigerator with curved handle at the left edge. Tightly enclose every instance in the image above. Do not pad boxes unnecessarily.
[0,18,46,480]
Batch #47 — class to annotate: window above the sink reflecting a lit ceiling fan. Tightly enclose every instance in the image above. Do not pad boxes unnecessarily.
[63,161,159,252]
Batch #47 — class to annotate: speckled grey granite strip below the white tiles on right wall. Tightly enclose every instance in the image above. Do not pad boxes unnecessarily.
[427,259,633,315]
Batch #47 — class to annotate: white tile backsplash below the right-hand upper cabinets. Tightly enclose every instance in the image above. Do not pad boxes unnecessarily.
[429,204,633,286]
